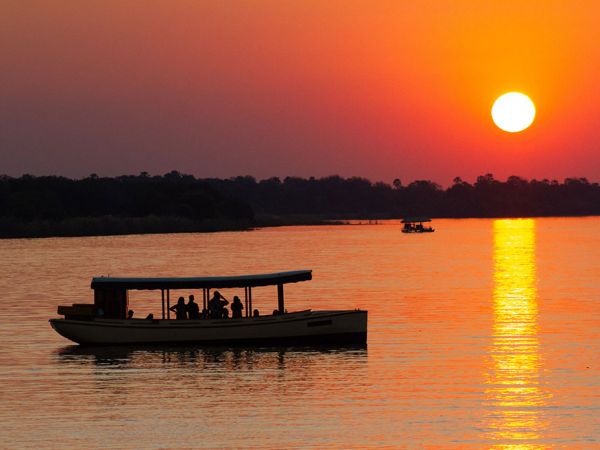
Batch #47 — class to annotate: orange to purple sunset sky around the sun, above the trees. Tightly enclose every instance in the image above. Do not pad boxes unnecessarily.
[0,0,600,185]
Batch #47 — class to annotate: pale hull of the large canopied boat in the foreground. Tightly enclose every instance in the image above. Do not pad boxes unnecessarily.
[50,310,367,345]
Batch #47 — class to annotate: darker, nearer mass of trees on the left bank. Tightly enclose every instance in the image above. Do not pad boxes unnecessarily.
[0,171,254,237]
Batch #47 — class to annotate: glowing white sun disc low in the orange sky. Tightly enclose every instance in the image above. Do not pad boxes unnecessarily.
[492,92,535,133]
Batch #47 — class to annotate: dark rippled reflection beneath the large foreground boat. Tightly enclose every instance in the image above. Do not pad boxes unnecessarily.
[55,345,367,406]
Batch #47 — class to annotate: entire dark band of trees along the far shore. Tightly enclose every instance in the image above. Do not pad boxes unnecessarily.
[0,171,600,238]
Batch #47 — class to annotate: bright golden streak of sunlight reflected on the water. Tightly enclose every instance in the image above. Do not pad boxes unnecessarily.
[484,219,548,448]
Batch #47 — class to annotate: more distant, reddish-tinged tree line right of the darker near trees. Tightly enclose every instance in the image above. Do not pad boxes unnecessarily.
[206,174,600,219]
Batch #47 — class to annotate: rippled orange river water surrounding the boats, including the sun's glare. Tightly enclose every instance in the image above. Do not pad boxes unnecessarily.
[0,218,600,449]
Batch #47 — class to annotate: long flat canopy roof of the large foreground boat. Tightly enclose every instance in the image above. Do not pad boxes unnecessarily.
[91,270,312,289]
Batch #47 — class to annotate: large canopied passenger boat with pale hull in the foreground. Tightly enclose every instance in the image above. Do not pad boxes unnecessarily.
[50,270,367,345]
